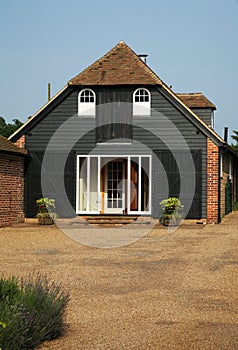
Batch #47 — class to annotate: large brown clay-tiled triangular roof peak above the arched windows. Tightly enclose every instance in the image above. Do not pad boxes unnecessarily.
[68,41,162,85]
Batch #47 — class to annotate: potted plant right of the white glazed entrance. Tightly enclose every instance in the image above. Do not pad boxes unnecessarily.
[160,197,183,226]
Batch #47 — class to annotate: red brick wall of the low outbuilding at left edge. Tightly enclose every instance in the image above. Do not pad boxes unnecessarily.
[0,153,24,226]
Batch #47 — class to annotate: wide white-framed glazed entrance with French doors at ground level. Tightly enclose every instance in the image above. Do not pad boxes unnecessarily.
[76,155,151,215]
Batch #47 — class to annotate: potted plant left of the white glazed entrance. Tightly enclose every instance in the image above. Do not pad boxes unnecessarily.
[36,198,55,225]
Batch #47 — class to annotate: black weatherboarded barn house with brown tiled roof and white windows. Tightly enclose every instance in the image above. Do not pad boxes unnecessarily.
[10,41,237,223]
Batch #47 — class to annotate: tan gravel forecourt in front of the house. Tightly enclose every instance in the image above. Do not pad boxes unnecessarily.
[0,213,238,350]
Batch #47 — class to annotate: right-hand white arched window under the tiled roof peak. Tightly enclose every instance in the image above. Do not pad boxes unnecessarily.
[133,88,151,115]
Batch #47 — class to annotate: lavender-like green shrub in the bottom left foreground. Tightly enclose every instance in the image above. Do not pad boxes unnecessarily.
[0,274,69,350]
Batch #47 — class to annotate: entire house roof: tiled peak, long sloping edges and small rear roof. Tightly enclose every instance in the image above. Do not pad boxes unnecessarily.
[9,41,225,145]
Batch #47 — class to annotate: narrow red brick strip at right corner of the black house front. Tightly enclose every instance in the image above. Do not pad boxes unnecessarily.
[207,139,220,224]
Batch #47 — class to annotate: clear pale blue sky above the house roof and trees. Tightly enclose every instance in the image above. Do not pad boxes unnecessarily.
[0,0,238,142]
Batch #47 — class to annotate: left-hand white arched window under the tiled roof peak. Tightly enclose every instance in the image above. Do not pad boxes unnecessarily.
[78,89,96,117]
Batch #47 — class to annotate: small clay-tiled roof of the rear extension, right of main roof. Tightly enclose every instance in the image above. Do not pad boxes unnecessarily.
[176,92,216,109]
